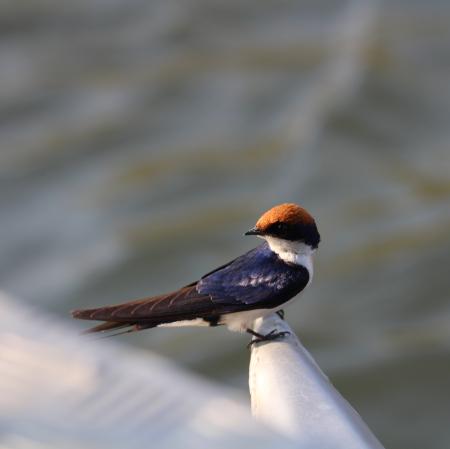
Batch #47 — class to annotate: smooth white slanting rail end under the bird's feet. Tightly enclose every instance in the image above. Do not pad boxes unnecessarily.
[249,314,382,449]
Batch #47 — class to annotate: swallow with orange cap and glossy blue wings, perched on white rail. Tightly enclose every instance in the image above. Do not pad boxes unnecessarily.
[72,203,320,343]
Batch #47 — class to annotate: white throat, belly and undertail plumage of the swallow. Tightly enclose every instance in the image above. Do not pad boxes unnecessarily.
[158,236,315,332]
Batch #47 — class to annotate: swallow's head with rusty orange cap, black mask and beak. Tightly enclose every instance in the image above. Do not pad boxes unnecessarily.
[245,203,320,249]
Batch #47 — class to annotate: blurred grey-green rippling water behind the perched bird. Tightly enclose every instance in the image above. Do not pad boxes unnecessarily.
[0,0,450,449]
